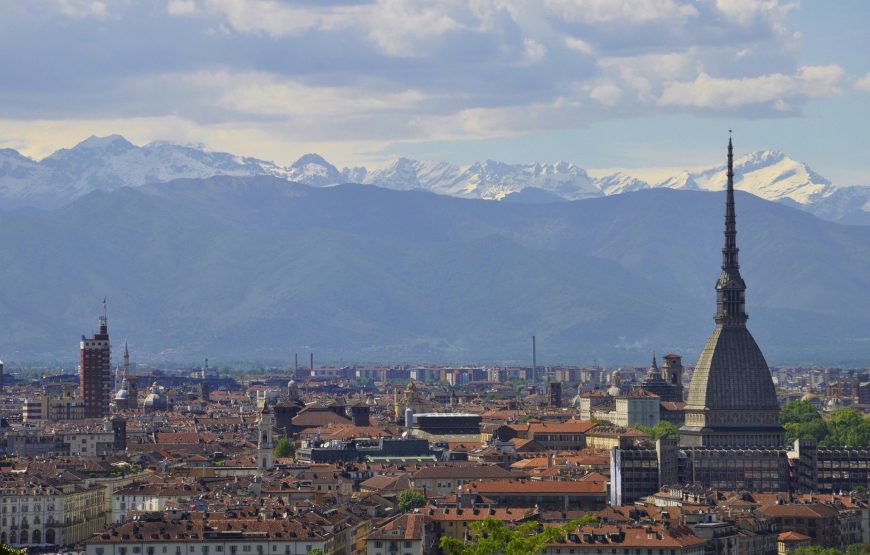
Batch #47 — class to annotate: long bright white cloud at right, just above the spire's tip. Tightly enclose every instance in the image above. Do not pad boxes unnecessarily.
[658,65,845,111]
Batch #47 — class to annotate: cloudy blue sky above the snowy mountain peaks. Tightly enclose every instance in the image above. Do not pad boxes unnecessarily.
[0,0,870,185]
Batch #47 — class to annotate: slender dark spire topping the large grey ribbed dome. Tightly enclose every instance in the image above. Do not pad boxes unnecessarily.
[716,130,748,326]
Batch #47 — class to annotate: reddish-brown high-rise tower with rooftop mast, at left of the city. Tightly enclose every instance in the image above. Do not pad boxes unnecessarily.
[79,299,112,418]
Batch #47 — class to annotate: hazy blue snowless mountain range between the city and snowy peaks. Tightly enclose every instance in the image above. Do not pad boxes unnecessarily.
[0,175,870,365]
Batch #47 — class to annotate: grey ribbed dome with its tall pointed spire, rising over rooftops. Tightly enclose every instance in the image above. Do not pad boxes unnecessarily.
[680,138,785,447]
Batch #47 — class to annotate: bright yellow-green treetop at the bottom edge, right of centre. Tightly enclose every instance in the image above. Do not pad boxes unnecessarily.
[439,518,577,555]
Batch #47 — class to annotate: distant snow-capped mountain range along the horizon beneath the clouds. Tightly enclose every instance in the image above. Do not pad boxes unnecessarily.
[0,135,870,224]
